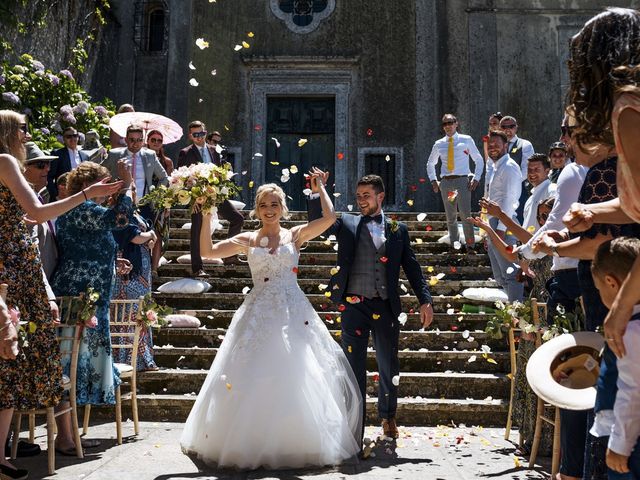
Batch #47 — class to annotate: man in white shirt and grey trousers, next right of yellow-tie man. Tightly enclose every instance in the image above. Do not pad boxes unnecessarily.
[487,130,524,302]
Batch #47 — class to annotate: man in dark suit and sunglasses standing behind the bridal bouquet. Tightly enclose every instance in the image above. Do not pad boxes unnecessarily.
[178,120,244,277]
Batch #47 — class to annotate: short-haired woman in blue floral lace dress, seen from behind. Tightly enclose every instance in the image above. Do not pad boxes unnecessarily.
[51,162,133,451]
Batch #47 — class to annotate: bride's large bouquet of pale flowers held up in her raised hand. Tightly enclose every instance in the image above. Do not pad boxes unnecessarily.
[140,163,240,214]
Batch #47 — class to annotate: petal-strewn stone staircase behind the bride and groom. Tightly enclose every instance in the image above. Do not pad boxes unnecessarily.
[131,210,509,426]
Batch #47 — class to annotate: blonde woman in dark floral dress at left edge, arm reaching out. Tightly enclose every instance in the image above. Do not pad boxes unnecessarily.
[0,110,122,478]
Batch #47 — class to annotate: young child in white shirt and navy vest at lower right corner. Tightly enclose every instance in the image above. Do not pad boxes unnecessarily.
[591,237,640,480]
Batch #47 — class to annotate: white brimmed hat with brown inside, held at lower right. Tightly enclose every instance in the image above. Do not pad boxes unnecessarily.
[527,332,604,410]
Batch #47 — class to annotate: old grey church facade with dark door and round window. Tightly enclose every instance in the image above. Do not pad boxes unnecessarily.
[91,0,639,211]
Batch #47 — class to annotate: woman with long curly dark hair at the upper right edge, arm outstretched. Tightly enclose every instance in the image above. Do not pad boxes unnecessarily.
[567,8,640,357]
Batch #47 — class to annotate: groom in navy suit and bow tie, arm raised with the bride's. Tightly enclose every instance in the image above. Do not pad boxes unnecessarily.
[308,173,433,438]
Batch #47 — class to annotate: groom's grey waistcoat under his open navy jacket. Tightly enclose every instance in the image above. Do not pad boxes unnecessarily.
[346,225,389,300]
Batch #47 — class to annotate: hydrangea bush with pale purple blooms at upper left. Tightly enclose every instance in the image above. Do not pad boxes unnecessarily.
[0,54,115,150]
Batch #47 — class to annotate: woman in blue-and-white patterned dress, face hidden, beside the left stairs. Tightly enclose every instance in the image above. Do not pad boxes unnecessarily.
[113,214,158,370]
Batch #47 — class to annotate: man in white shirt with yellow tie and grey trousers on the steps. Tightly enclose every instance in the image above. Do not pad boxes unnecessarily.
[427,113,484,253]
